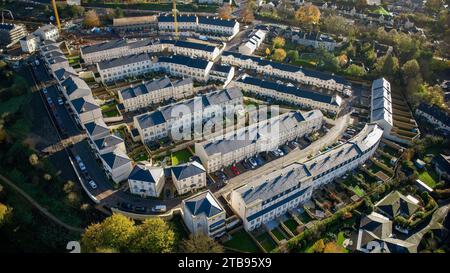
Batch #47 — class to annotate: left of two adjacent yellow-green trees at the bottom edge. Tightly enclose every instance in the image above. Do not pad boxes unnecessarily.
[81,214,135,252]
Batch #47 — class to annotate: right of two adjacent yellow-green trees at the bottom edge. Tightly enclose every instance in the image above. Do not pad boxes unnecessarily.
[131,217,175,253]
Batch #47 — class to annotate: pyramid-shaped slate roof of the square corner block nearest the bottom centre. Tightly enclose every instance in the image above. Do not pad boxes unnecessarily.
[183,190,224,218]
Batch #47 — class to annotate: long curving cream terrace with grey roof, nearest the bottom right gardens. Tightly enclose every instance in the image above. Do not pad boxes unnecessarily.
[230,123,383,230]
